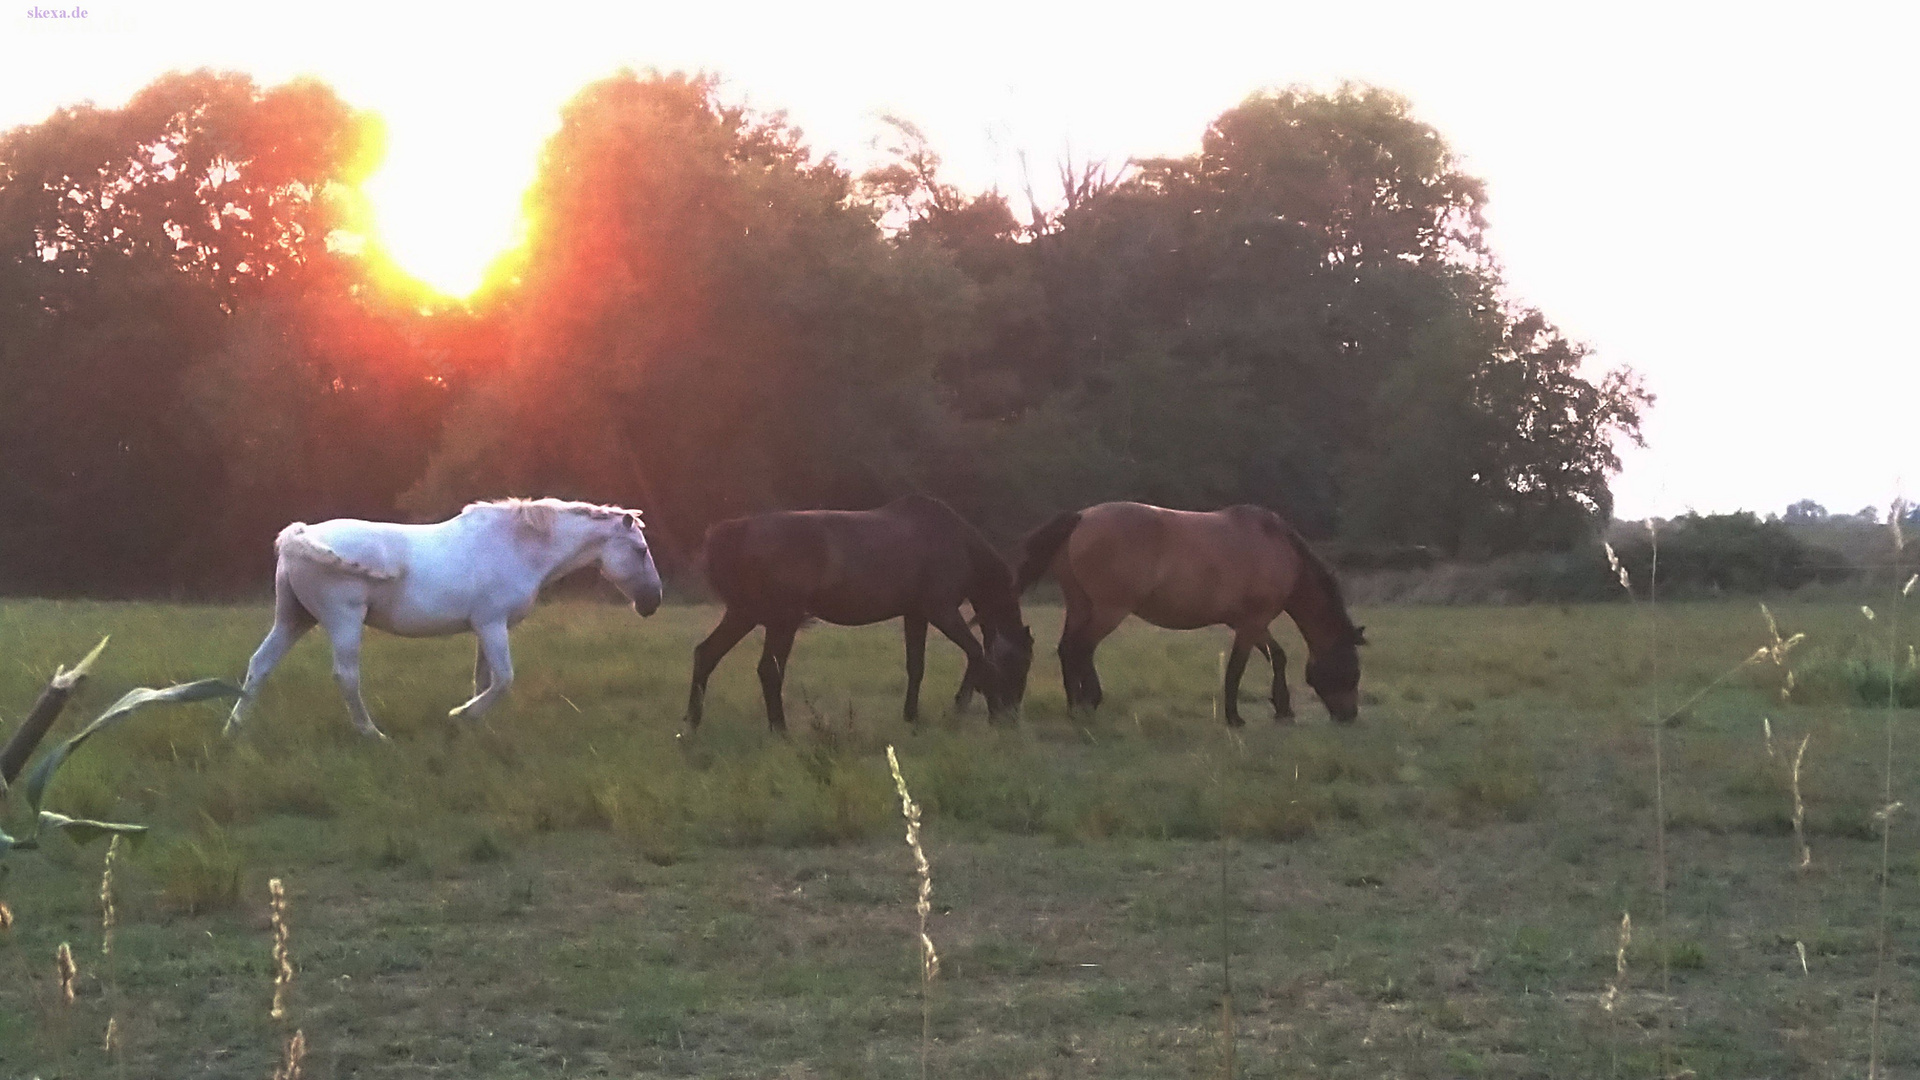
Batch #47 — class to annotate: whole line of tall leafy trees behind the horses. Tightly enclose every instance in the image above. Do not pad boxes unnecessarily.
[0,71,1651,594]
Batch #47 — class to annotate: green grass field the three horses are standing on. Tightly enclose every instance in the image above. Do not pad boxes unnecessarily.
[0,601,1920,1080]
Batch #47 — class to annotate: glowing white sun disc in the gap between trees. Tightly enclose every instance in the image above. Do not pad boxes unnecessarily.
[361,115,540,298]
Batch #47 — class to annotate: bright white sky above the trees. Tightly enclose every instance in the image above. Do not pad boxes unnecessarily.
[0,0,1920,517]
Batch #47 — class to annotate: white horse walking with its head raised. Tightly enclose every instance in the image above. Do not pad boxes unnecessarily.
[227,500,660,738]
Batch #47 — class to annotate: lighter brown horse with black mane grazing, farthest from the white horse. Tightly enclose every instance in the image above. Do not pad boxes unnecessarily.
[1018,502,1365,726]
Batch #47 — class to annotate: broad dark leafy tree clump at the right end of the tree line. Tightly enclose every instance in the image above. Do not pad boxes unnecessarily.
[906,86,1649,550]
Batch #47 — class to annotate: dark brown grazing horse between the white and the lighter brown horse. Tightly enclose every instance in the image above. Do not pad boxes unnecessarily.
[687,496,1033,730]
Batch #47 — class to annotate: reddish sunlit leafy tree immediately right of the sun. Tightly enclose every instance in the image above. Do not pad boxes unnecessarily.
[409,73,972,540]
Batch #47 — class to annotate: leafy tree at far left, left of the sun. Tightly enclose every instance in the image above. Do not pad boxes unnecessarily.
[0,71,397,592]
